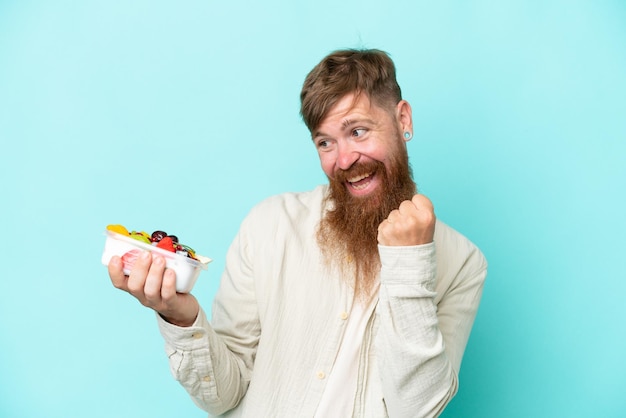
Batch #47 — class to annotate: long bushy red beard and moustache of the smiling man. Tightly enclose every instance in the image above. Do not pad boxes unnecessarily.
[317,140,416,296]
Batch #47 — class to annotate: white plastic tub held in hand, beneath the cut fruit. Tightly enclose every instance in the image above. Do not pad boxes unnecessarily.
[102,230,211,293]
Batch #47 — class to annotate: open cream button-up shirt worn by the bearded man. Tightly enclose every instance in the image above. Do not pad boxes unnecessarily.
[158,186,487,418]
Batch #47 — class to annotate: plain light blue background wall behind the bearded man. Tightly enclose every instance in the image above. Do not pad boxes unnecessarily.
[0,0,626,418]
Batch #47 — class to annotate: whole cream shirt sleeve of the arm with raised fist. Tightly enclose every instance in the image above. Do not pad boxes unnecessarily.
[376,229,486,417]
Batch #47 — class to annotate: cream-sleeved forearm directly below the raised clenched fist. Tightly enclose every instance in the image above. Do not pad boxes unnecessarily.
[377,243,457,417]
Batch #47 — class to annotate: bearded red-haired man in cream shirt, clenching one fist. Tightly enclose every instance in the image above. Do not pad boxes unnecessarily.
[109,50,486,418]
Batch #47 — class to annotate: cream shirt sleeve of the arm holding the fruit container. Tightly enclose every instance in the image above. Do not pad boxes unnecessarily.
[157,220,260,415]
